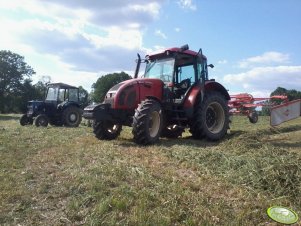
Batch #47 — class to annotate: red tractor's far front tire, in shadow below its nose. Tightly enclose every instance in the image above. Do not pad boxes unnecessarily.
[92,121,122,140]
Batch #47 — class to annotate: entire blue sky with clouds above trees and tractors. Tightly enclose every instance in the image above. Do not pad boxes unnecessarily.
[0,0,301,97]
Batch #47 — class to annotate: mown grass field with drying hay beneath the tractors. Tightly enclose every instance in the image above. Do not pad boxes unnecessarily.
[0,115,301,225]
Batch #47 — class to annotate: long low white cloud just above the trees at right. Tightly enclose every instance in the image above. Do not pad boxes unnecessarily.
[223,66,301,93]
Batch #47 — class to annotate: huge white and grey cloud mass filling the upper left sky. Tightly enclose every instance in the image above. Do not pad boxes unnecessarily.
[0,0,163,88]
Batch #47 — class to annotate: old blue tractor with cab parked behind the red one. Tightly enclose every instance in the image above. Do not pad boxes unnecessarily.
[20,83,82,127]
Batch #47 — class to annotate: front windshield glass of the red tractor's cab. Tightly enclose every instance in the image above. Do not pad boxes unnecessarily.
[144,58,175,82]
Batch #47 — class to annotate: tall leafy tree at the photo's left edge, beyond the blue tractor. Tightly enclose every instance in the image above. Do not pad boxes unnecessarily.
[0,50,35,112]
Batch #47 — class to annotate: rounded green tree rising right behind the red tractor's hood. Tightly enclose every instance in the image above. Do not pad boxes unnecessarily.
[92,72,132,103]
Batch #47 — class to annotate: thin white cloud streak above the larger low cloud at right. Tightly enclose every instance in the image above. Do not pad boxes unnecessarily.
[239,52,289,68]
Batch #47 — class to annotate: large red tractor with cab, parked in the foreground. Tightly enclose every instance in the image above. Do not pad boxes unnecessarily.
[83,45,230,145]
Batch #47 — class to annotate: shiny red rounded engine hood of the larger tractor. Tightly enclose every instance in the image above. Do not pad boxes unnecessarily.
[104,78,164,109]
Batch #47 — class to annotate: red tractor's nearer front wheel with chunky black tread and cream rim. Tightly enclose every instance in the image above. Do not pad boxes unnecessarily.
[132,99,163,145]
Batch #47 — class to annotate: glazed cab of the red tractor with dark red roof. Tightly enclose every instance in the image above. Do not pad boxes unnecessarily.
[138,46,213,103]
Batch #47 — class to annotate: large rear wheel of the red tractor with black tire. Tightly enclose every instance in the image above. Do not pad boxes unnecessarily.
[190,92,229,141]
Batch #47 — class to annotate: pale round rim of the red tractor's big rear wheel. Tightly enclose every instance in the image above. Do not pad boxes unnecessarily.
[206,102,225,133]
